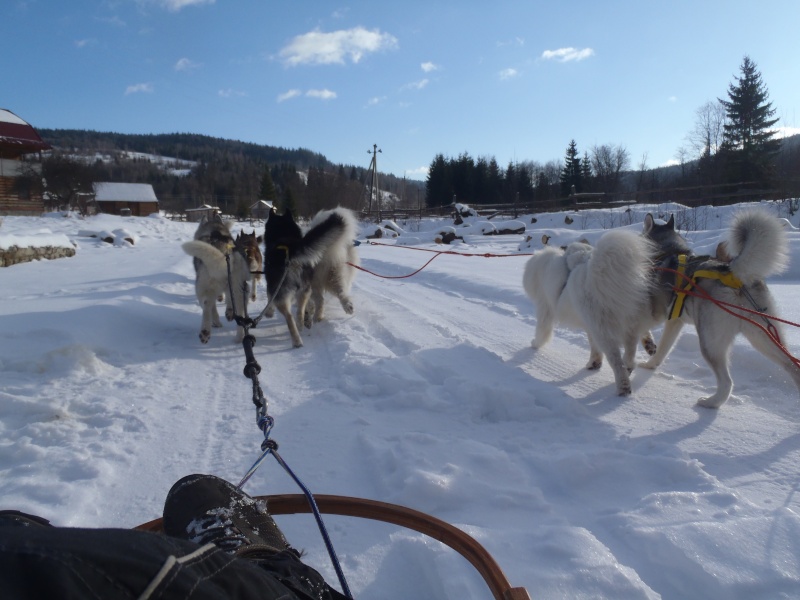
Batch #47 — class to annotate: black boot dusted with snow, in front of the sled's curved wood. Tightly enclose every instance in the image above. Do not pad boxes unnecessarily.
[163,475,297,558]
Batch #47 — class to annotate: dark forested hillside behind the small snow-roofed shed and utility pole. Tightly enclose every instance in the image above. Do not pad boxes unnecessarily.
[34,129,422,216]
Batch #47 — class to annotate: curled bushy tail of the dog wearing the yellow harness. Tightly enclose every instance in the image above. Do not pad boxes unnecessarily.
[728,209,789,285]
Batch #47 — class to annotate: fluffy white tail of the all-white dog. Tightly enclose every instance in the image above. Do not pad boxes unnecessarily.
[586,229,654,322]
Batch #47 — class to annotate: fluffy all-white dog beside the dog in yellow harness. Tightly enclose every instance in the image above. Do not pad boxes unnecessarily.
[522,230,655,395]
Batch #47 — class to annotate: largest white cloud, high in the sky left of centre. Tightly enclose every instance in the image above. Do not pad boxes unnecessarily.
[280,27,397,67]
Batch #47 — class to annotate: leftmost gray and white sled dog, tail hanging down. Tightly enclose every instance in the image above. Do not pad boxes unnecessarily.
[182,214,250,344]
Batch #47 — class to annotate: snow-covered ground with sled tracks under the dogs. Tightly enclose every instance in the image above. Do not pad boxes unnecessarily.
[0,205,800,600]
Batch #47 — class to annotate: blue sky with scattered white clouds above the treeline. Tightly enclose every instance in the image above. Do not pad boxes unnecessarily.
[0,0,800,179]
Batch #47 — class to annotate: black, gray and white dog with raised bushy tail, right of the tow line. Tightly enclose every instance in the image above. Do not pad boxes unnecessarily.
[264,207,358,348]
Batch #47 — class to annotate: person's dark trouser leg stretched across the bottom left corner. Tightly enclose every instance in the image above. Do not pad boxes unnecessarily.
[0,513,300,600]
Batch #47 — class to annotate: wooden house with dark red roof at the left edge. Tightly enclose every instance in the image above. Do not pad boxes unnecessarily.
[0,108,51,215]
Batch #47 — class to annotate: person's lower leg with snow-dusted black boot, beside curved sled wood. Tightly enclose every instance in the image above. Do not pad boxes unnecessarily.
[163,475,345,600]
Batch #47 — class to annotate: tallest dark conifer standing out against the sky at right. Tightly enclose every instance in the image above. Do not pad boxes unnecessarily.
[719,56,780,184]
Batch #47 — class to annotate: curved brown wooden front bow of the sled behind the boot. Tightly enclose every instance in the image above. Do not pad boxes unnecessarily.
[136,494,531,600]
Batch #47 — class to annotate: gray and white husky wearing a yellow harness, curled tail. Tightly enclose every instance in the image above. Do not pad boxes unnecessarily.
[641,209,800,408]
